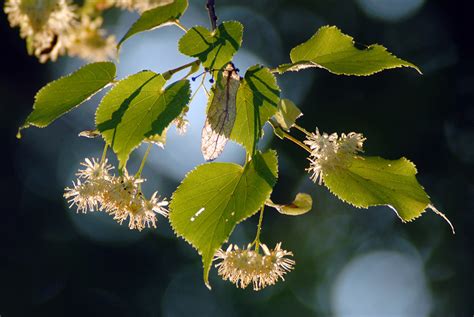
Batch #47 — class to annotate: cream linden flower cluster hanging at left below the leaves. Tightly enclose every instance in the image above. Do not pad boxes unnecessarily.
[64,159,168,231]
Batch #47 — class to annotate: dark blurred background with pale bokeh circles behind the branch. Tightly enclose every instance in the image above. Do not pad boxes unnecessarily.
[0,0,474,317]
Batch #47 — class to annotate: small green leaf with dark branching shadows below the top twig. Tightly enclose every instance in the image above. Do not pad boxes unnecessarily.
[179,21,244,70]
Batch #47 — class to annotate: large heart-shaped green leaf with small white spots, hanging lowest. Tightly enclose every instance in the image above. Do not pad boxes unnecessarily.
[169,151,278,287]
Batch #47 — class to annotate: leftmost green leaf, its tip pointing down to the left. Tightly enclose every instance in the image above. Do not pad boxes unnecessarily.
[20,62,115,135]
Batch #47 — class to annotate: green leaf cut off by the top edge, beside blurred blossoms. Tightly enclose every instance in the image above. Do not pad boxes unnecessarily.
[117,0,188,49]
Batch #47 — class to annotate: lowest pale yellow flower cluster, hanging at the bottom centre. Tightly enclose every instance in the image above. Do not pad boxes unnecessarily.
[214,243,295,291]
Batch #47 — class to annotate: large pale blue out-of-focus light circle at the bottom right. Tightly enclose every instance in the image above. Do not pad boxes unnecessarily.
[331,251,431,317]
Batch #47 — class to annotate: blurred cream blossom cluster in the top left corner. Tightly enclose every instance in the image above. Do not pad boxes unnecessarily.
[4,0,116,63]
